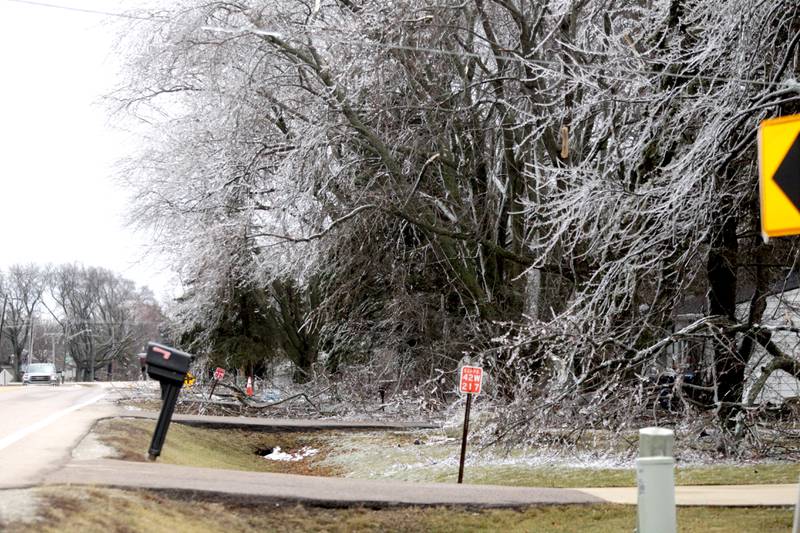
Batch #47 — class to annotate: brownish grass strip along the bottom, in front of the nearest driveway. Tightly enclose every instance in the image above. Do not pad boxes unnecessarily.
[3,487,792,533]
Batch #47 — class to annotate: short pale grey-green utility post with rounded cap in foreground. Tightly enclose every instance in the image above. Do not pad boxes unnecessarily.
[636,428,677,533]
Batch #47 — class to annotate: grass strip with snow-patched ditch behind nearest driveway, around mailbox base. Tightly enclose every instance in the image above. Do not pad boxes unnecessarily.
[95,419,800,487]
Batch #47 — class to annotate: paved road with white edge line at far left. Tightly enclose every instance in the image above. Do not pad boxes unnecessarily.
[0,385,113,489]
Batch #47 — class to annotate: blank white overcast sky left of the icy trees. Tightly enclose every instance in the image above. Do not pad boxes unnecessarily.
[0,0,175,298]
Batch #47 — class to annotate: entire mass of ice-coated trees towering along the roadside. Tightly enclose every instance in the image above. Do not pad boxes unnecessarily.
[115,0,800,432]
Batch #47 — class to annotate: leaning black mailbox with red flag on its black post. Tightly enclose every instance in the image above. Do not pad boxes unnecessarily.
[146,342,193,461]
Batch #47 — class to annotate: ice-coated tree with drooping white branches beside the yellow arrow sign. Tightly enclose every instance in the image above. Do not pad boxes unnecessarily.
[482,0,800,436]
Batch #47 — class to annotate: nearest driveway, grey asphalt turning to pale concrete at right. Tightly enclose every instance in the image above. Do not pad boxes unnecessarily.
[45,459,798,507]
